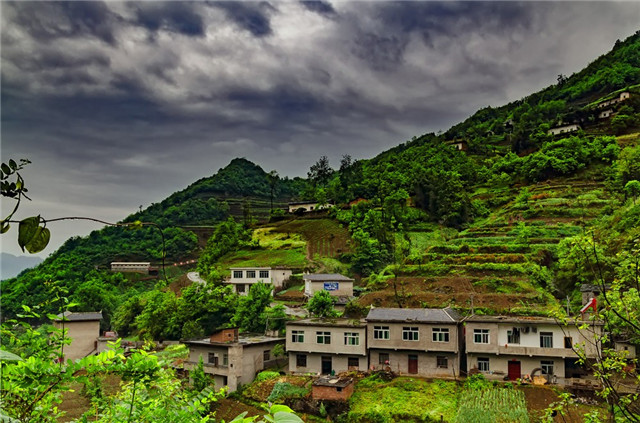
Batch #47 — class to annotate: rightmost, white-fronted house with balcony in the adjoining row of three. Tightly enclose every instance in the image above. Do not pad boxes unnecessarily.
[465,316,603,380]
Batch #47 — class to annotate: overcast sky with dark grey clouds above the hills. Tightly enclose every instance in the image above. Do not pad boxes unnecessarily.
[0,1,640,256]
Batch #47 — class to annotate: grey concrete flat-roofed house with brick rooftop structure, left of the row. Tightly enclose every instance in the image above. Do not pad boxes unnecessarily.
[184,328,284,392]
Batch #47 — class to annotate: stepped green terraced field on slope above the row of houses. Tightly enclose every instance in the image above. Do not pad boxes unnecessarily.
[360,174,610,314]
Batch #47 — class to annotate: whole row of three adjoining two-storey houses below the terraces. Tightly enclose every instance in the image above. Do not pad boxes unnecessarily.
[286,308,620,380]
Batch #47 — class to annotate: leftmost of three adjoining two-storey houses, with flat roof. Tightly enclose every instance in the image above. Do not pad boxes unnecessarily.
[286,319,368,374]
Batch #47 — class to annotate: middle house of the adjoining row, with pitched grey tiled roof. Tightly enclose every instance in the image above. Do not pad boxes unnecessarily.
[366,308,460,377]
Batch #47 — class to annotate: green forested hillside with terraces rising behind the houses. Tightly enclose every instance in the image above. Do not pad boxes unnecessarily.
[2,30,640,339]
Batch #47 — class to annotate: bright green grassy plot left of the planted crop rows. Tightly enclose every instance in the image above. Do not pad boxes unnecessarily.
[348,375,458,422]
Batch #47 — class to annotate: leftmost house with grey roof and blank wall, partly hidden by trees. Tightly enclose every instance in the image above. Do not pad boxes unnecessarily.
[53,311,102,360]
